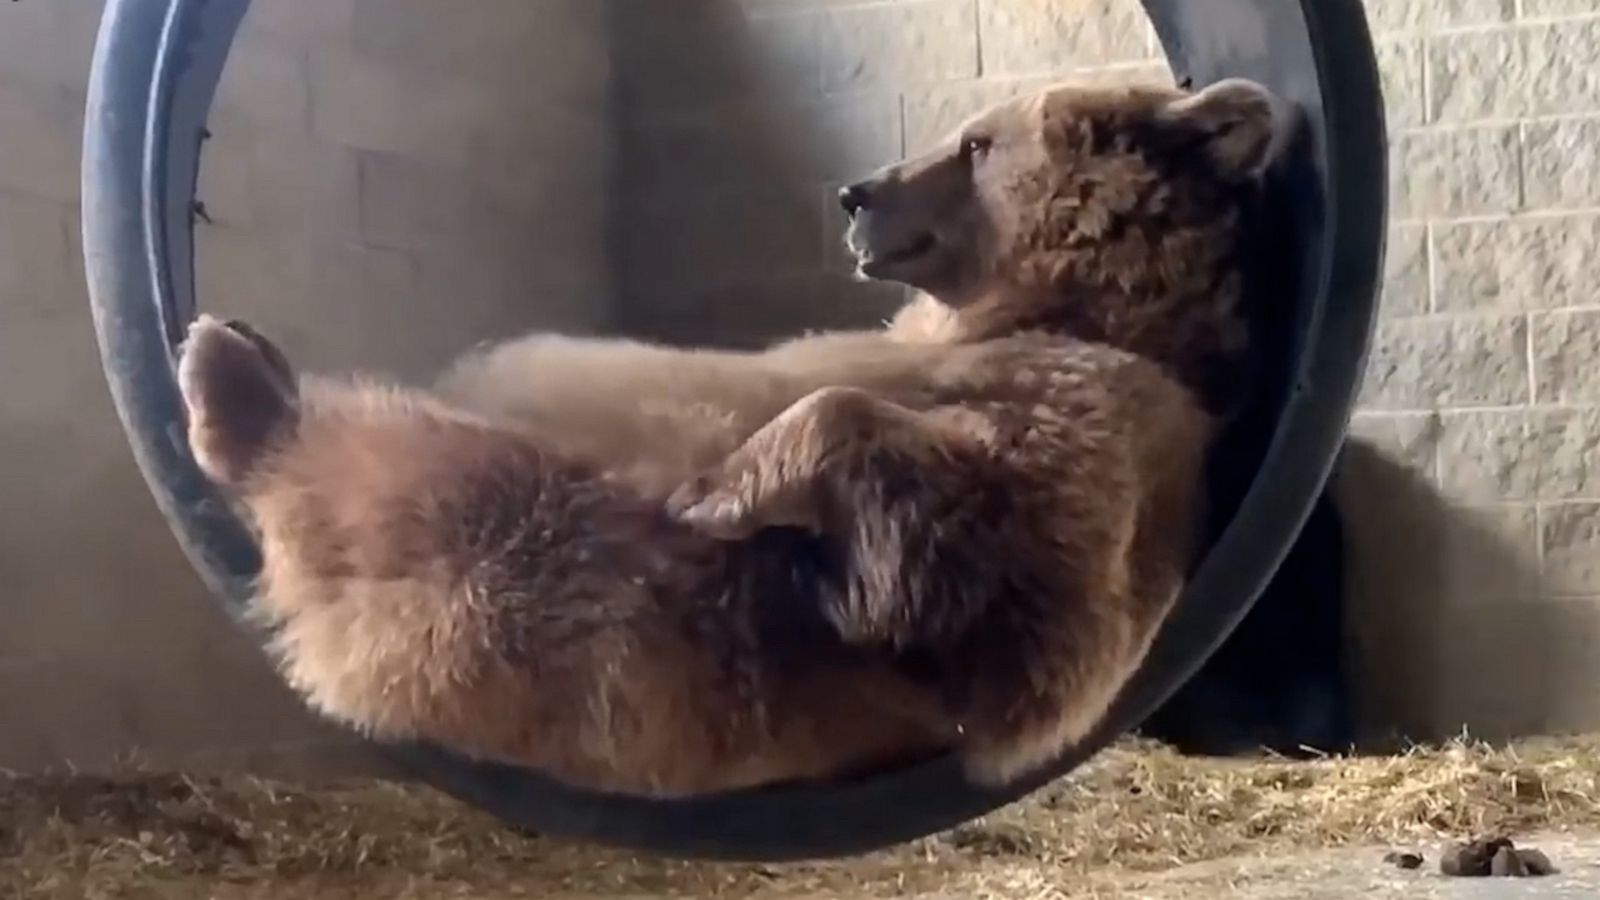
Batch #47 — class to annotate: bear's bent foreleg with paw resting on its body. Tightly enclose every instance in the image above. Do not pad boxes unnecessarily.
[669,381,1003,647]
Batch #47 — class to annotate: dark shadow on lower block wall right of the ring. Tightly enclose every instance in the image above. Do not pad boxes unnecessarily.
[1334,438,1600,749]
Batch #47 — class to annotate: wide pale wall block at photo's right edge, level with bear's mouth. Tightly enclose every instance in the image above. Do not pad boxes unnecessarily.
[1434,216,1600,312]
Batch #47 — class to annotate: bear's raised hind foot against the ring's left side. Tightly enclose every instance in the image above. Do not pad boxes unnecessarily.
[178,315,299,485]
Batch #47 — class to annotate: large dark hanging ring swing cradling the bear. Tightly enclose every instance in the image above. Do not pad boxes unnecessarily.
[83,0,1387,860]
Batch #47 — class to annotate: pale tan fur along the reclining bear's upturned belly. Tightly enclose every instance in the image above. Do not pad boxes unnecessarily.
[434,312,953,496]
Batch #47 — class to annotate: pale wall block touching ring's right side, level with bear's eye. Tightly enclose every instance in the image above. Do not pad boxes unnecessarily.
[1390,127,1522,219]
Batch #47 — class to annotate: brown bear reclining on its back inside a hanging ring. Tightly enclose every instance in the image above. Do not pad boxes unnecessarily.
[179,80,1275,796]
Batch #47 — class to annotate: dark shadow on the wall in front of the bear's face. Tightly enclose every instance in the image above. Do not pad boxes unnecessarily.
[608,0,904,346]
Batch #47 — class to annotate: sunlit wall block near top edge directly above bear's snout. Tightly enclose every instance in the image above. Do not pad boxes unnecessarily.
[821,0,979,93]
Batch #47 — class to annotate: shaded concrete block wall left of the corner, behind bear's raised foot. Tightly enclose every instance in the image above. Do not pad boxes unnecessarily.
[0,0,613,772]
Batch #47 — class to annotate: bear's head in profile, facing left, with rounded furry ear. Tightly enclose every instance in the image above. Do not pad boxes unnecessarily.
[840,78,1280,408]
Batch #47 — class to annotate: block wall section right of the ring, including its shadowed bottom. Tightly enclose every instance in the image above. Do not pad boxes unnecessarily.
[1341,0,1600,737]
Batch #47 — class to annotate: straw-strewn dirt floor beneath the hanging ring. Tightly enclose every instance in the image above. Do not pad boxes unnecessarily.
[0,738,1600,900]
